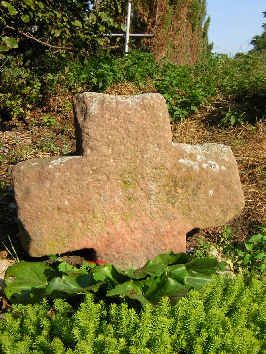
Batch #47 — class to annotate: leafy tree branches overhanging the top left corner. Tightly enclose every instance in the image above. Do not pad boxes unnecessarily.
[0,0,127,53]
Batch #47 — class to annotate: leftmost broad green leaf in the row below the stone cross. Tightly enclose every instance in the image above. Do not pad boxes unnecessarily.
[5,261,51,303]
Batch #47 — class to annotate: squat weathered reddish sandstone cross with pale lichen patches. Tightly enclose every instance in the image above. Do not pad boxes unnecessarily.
[13,92,244,268]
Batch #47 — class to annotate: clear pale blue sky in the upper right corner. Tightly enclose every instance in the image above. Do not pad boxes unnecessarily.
[207,0,266,56]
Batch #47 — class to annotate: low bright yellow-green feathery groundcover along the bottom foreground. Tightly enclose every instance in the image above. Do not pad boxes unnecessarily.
[0,275,266,354]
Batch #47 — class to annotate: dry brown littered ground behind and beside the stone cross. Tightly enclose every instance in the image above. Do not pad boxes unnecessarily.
[0,95,266,263]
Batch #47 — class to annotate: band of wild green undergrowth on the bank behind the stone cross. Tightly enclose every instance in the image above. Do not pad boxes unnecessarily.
[0,51,266,125]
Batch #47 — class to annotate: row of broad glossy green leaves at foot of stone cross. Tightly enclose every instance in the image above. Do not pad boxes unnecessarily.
[5,251,224,305]
